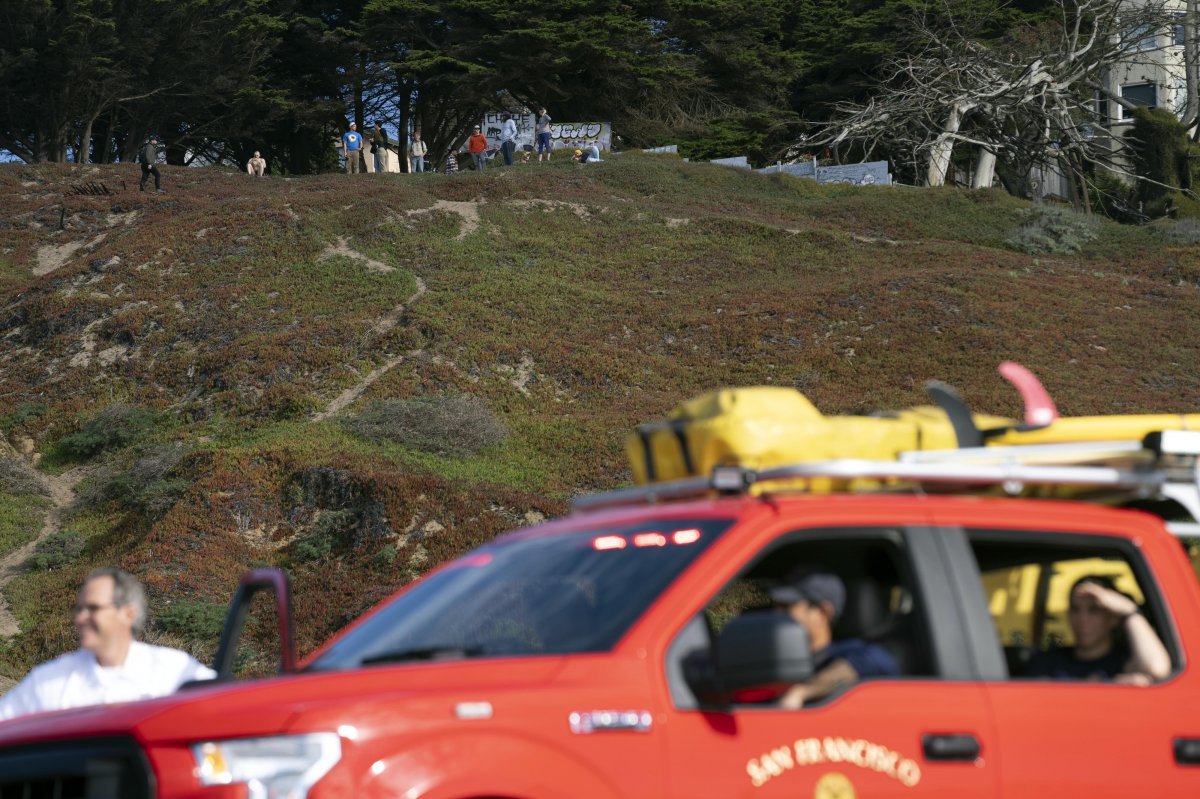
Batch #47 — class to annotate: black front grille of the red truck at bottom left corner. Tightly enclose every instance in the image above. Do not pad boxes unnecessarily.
[0,738,155,799]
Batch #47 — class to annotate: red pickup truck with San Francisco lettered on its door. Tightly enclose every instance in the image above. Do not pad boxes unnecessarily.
[0,443,1200,799]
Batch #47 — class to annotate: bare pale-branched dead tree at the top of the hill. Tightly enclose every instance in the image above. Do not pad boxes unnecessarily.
[791,0,1180,193]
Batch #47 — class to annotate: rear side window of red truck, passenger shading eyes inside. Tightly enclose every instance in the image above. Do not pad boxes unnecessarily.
[968,530,1180,684]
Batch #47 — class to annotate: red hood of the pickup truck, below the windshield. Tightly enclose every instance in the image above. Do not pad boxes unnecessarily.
[0,657,566,746]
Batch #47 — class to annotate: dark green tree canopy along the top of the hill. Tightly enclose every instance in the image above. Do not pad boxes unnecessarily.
[0,0,1200,189]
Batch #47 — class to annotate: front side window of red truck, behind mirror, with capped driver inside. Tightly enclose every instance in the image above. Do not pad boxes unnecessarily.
[677,529,932,709]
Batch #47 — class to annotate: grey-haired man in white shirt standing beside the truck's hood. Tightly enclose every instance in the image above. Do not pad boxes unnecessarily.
[0,569,216,720]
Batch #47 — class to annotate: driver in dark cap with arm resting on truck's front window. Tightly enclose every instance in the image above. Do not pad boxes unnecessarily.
[768,567,900,710]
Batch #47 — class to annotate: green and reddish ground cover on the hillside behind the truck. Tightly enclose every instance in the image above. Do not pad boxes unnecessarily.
[0,154,1200,677]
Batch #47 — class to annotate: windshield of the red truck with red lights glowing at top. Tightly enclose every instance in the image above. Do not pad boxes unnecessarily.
[308,518,731,671]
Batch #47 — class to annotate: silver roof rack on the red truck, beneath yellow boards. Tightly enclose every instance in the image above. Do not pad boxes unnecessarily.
[572,431,1200,536]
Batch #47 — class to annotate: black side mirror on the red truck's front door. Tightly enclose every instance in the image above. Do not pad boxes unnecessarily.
[690,609,812,702]
